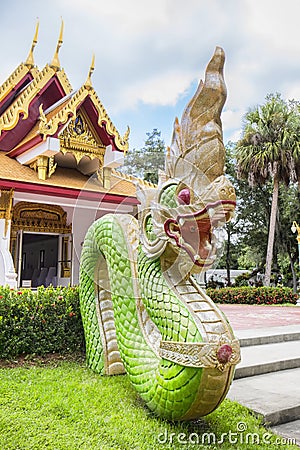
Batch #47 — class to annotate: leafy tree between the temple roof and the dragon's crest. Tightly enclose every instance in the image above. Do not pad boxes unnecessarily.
[122,128,165,183]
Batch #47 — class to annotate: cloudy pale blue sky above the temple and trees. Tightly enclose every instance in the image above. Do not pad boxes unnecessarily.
[0,0,300,149]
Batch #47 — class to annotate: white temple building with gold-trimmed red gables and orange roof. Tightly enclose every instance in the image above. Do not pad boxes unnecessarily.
[0,23,145,288]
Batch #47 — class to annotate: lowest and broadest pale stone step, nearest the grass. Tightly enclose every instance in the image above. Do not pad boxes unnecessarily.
[227,366,300,426]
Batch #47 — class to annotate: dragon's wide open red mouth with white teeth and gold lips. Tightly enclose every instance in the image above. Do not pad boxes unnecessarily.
[164,200,236,268]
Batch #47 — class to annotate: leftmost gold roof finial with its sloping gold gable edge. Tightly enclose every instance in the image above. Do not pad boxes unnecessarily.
[0,22,39,102]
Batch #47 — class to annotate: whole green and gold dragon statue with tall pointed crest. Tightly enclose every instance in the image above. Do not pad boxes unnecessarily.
[80,47,240,420]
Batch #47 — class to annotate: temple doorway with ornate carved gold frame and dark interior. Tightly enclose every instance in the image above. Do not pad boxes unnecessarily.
[11,202,73,288]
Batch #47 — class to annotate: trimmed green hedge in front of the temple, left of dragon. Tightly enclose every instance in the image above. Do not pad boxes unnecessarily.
[0,286,84,359]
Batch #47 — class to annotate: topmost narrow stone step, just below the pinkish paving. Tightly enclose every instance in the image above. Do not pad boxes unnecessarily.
[235,325,300,347]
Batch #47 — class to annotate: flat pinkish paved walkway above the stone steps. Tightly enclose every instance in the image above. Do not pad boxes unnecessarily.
[218,304,300,330]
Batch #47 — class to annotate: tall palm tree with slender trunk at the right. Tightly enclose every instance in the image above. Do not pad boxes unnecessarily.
[236,94,300,286]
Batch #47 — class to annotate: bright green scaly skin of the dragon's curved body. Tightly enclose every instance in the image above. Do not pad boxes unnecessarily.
[80,215,237,419]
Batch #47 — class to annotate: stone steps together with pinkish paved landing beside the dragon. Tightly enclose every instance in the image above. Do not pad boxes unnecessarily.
[218,305,300,448]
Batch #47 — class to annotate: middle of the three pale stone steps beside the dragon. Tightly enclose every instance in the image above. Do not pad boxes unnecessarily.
[234,340,300,380]
